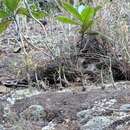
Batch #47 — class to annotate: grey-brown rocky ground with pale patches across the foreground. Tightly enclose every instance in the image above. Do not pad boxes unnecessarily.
[0,83,130,130]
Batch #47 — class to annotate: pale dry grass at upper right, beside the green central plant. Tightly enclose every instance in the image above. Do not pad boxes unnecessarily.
[93,0,130,60]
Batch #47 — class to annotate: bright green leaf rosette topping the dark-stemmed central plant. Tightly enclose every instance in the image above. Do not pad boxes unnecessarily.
[57,3,101,33]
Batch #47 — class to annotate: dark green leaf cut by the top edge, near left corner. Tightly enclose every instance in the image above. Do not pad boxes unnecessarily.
[3,0,20,12]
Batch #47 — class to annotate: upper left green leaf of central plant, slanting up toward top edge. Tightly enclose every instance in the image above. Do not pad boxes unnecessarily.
[63,2,82,21]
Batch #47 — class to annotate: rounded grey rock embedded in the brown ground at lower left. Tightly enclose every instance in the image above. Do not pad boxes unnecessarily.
[21,105,46,120]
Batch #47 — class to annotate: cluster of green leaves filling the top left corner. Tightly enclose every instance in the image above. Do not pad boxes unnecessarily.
[0,0,46,33]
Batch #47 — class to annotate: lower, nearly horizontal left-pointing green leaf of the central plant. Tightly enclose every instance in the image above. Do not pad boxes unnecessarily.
[57,16,80,25]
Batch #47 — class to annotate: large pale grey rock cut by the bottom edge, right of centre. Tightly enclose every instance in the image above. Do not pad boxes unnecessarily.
[81,116,113,130]
